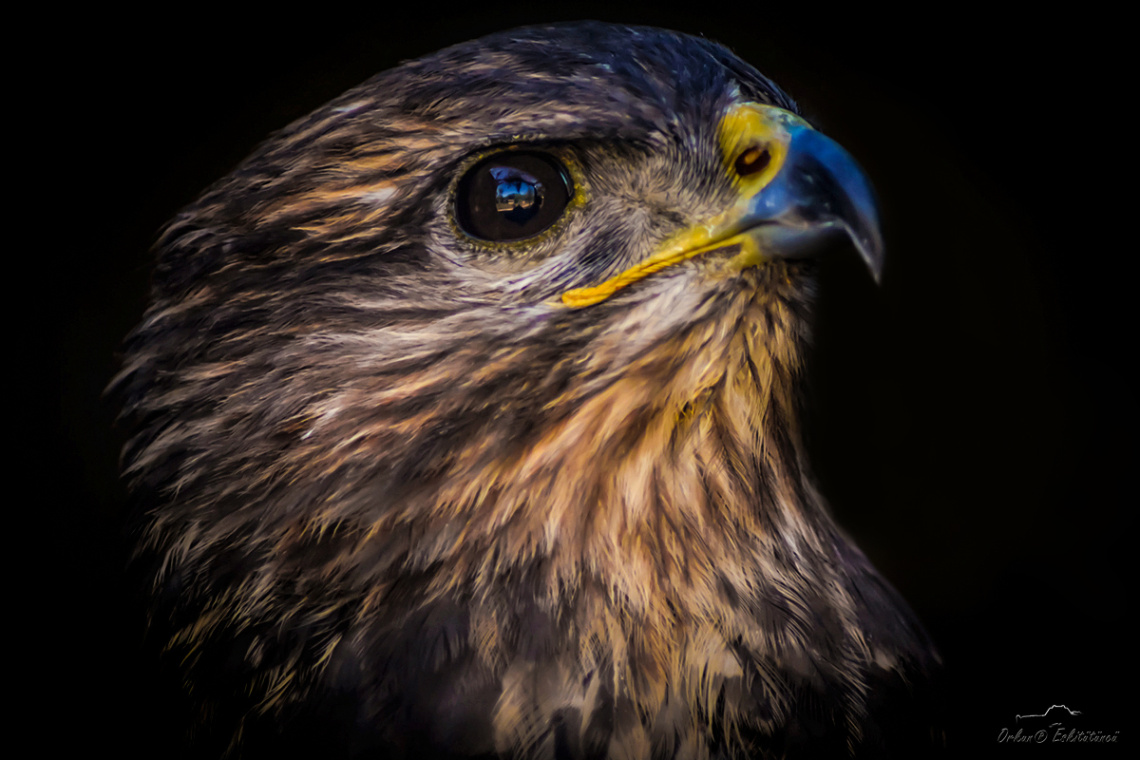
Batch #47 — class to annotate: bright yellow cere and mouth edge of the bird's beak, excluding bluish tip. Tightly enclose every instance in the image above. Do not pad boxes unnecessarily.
[562,103,804,309]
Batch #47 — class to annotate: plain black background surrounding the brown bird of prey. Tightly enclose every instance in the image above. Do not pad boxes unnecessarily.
[51,2,1138,758]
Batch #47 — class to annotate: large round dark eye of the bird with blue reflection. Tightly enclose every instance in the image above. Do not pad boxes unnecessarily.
[455,150,573,242]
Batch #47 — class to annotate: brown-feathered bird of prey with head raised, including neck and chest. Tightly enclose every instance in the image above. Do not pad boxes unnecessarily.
[116,24,937,759]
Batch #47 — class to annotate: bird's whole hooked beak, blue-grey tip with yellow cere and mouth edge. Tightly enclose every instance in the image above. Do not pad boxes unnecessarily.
[562,103,882,307]
